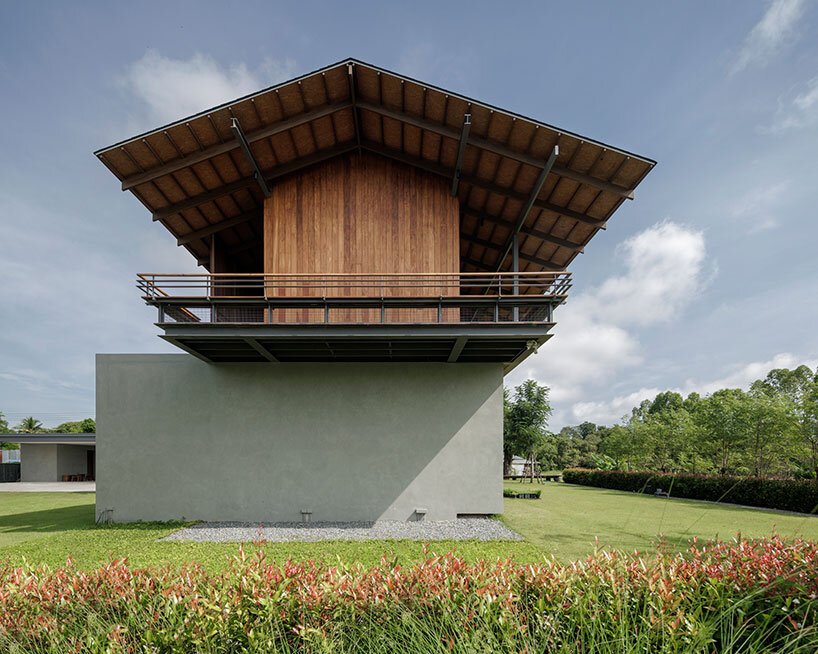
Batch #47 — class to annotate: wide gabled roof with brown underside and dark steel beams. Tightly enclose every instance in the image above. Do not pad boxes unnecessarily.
[95,59,656,271]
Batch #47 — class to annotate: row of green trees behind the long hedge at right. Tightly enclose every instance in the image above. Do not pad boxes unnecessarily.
[504,366,818,479]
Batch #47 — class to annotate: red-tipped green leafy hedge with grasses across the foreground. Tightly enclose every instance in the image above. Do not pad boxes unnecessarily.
[0,538,818,652]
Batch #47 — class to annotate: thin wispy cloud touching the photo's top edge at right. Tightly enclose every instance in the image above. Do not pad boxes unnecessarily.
[732,0,806,73]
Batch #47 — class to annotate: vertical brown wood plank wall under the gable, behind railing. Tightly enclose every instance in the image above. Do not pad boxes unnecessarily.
[264,149,460,322]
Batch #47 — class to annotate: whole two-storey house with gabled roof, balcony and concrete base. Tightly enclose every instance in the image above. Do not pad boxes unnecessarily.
[91,60,654,521]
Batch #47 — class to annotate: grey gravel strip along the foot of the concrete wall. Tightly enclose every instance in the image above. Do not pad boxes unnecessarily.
[161,518,523,543]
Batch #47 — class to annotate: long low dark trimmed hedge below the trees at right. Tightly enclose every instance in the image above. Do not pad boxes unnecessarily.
[562,468,818,513]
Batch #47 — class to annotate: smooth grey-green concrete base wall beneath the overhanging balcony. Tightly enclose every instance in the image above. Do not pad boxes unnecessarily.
[96,354,503,522]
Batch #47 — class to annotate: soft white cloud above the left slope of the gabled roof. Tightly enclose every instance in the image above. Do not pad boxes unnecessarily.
[120,50,295,126]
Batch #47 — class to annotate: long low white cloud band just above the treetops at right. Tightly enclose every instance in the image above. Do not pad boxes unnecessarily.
[569,352,818,424]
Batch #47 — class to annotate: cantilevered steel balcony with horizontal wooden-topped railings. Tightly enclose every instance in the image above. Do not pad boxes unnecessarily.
[137,272,571,370]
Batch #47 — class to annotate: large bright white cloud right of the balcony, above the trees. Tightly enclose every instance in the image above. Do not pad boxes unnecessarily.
[512,222,706,403]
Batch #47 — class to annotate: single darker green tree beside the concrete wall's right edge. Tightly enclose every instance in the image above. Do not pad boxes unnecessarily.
[503,379,552,482]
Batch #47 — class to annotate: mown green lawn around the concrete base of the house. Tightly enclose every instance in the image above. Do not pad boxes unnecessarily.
[0,483,818,569]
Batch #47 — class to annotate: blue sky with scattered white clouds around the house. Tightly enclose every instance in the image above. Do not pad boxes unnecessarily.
[0,0,818,429]
